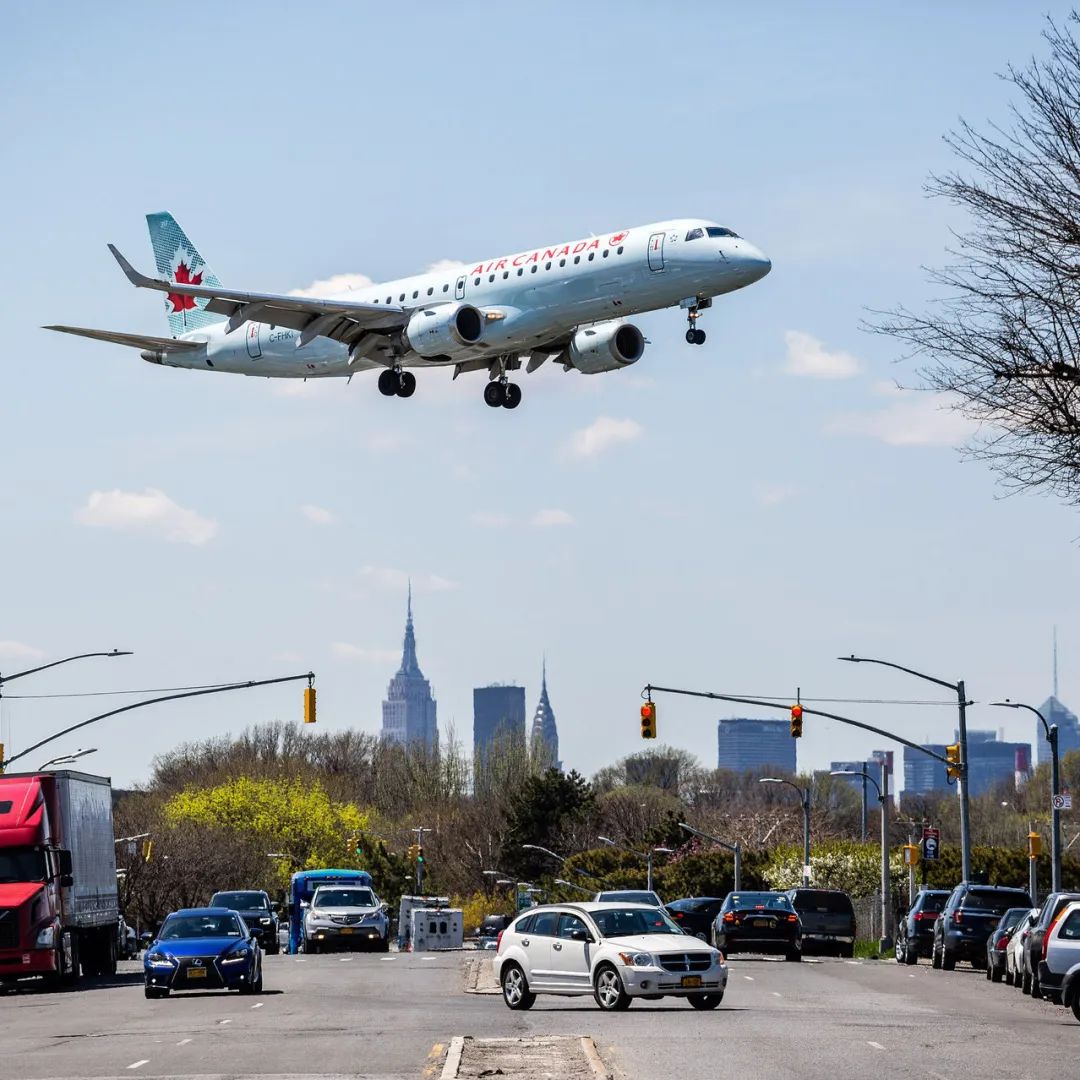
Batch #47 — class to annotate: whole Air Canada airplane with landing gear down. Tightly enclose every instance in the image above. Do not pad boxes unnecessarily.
[43,213,772,409]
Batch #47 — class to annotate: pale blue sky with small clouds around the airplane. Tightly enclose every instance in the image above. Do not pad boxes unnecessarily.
[0,3,1080,783]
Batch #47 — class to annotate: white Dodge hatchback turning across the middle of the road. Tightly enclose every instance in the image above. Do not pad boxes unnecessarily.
[494,903,728,1011]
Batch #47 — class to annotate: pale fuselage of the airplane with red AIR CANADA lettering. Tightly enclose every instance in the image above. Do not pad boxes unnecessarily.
[159,218,771,379]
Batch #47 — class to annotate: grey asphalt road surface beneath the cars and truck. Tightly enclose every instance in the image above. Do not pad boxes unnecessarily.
[0,953,1080,1080]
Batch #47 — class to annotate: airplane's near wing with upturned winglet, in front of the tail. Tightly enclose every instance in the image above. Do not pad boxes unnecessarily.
[109,244,408,348]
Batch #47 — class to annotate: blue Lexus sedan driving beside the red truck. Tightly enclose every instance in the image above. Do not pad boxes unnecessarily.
[143,907,262,998]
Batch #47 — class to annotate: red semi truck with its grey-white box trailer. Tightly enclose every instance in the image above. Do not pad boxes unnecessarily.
[0,771,120,983]
